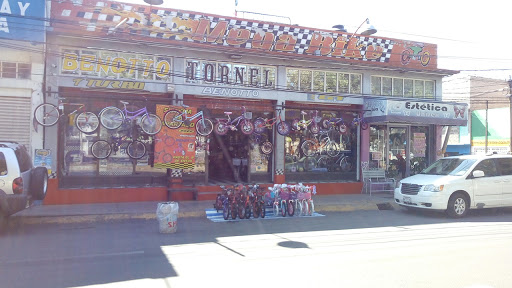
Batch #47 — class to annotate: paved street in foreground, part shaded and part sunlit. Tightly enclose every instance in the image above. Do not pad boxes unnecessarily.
[0,210,512,288]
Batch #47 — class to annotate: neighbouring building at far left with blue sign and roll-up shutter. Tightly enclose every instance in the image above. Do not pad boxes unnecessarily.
[0,0,46,157]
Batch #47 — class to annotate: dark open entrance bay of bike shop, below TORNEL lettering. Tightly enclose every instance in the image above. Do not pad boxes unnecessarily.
[176,95,276,186]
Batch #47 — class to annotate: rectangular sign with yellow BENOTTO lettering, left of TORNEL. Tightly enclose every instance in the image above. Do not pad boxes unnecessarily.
[61,49,172,81]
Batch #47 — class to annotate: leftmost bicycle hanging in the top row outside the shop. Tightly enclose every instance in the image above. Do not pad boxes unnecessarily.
[34,98,100,134]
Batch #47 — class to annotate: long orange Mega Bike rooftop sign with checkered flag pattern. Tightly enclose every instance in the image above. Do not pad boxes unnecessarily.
[52,0,437,70]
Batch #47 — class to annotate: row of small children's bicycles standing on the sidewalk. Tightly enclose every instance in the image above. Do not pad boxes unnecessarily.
[213,183,316,220]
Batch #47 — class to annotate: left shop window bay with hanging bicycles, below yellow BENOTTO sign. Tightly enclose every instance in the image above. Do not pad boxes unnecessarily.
[54,87,172,189]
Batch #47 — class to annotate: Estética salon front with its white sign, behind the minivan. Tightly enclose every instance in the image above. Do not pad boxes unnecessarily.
[362,100,467,180]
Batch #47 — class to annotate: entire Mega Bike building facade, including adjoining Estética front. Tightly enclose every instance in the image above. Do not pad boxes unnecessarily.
[45,0,467,203]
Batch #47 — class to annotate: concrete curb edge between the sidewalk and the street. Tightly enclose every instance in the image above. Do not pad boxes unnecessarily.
[8,201,399,226]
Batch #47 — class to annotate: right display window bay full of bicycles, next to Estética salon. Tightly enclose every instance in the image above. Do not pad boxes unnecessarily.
[284,101,362,183]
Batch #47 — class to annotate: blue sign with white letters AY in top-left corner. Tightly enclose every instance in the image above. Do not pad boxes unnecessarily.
[0,0,46,42]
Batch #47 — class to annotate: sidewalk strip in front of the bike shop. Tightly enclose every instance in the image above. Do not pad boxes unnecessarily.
[9,194,397,225]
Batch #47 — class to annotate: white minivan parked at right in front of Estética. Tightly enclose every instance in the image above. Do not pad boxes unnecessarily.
[394,154,512,217]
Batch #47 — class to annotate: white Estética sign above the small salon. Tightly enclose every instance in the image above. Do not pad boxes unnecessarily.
[364,99,468,126]
